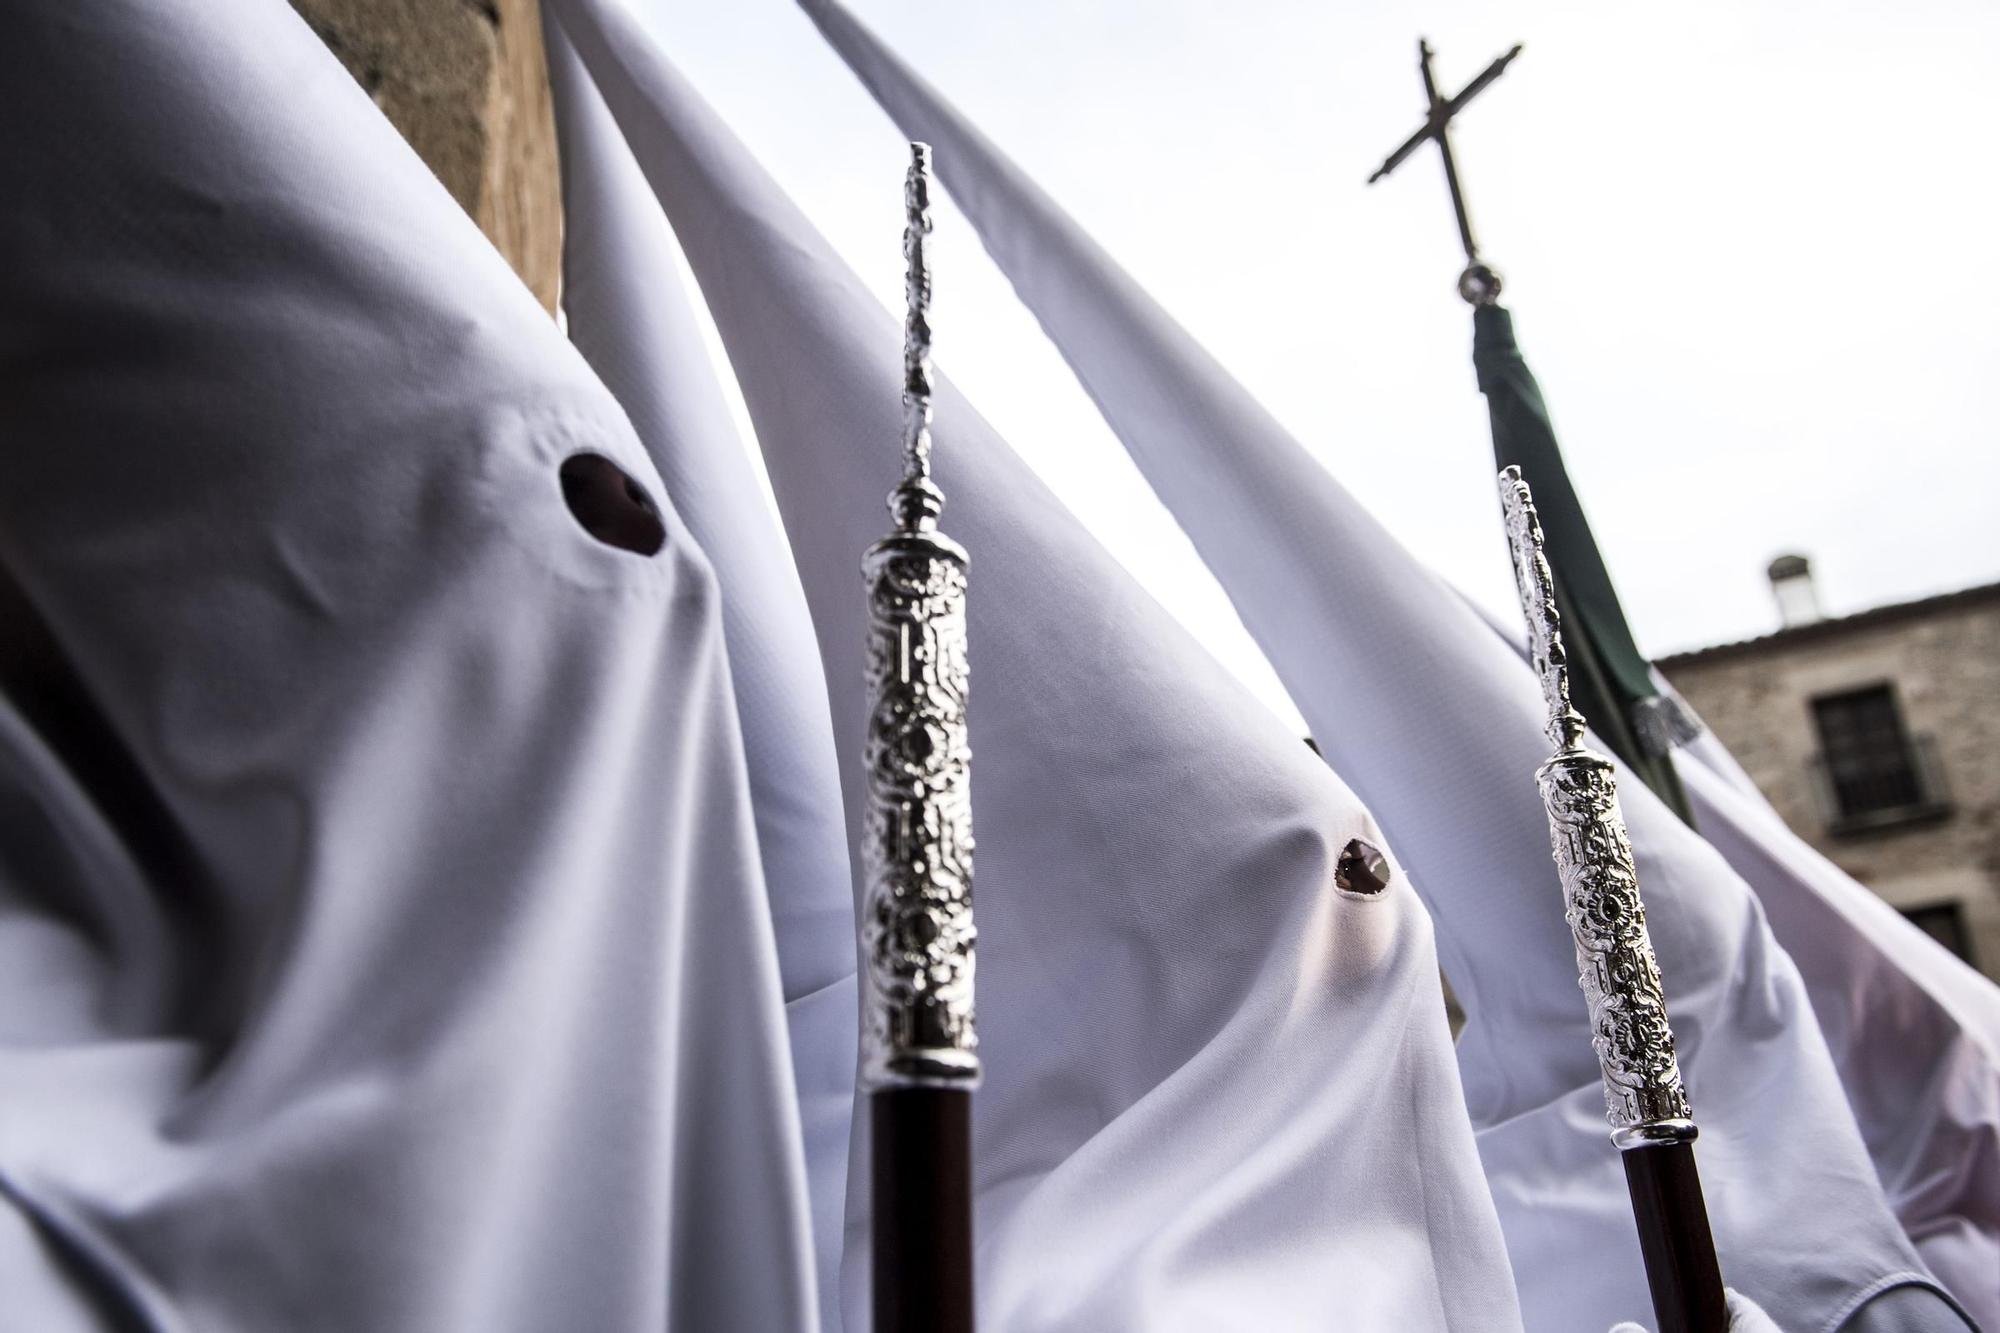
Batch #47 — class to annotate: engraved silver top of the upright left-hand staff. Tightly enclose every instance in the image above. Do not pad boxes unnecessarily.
[860,144,980,1091]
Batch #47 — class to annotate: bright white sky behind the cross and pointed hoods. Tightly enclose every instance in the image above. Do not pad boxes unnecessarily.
[642,0,2000,728]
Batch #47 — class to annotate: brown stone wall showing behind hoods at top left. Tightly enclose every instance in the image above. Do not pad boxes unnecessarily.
[292,0,562,310]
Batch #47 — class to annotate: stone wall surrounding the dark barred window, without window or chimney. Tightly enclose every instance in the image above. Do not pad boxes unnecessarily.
[1660,586,2000,979]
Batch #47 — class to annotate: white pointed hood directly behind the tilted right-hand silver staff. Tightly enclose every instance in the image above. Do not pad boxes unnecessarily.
[784,0,1960,1331]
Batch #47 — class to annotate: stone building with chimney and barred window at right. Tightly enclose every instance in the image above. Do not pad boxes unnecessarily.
[1658,556,2000,981]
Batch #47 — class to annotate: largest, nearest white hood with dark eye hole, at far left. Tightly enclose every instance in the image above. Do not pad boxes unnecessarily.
[0,0,814,1333]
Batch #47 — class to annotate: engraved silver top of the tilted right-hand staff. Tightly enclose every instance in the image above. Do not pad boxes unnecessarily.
[1500,468,1694,1149]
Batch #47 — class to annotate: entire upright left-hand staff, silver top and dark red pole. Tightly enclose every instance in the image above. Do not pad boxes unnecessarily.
[860,144,980,1333]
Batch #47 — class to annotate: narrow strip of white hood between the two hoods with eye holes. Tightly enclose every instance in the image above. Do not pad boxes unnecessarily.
[542,26,858,1329]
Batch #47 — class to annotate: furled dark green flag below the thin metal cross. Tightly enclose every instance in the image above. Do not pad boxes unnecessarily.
[1472,306,1696,825]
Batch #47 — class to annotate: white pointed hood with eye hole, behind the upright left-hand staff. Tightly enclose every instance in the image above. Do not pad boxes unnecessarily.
[546,0,1520,1333]
